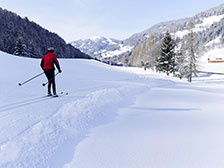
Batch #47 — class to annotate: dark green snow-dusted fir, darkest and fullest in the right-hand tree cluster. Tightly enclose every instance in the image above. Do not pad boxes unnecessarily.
[156,31,176,75]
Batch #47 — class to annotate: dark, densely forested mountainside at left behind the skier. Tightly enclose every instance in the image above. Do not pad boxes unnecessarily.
[0,8,91,58]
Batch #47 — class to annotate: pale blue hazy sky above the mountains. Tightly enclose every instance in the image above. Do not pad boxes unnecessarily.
[0,0,224,42]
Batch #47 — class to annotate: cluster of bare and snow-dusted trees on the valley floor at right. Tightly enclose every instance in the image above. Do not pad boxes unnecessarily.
[131,23,198,82]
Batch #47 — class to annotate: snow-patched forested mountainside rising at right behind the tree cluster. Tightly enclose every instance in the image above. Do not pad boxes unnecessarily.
[72,4,224,66]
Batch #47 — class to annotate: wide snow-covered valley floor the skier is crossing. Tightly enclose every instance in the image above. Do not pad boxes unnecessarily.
[0,52,224,168]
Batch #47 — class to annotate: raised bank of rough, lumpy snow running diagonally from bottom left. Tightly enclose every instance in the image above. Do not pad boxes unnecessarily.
[0,86,142,168]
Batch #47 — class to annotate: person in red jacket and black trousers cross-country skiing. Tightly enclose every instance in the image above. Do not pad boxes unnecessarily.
[40,47,62,96]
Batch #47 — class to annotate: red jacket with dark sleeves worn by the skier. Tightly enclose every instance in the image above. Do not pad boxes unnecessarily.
[40,52,60,70]
